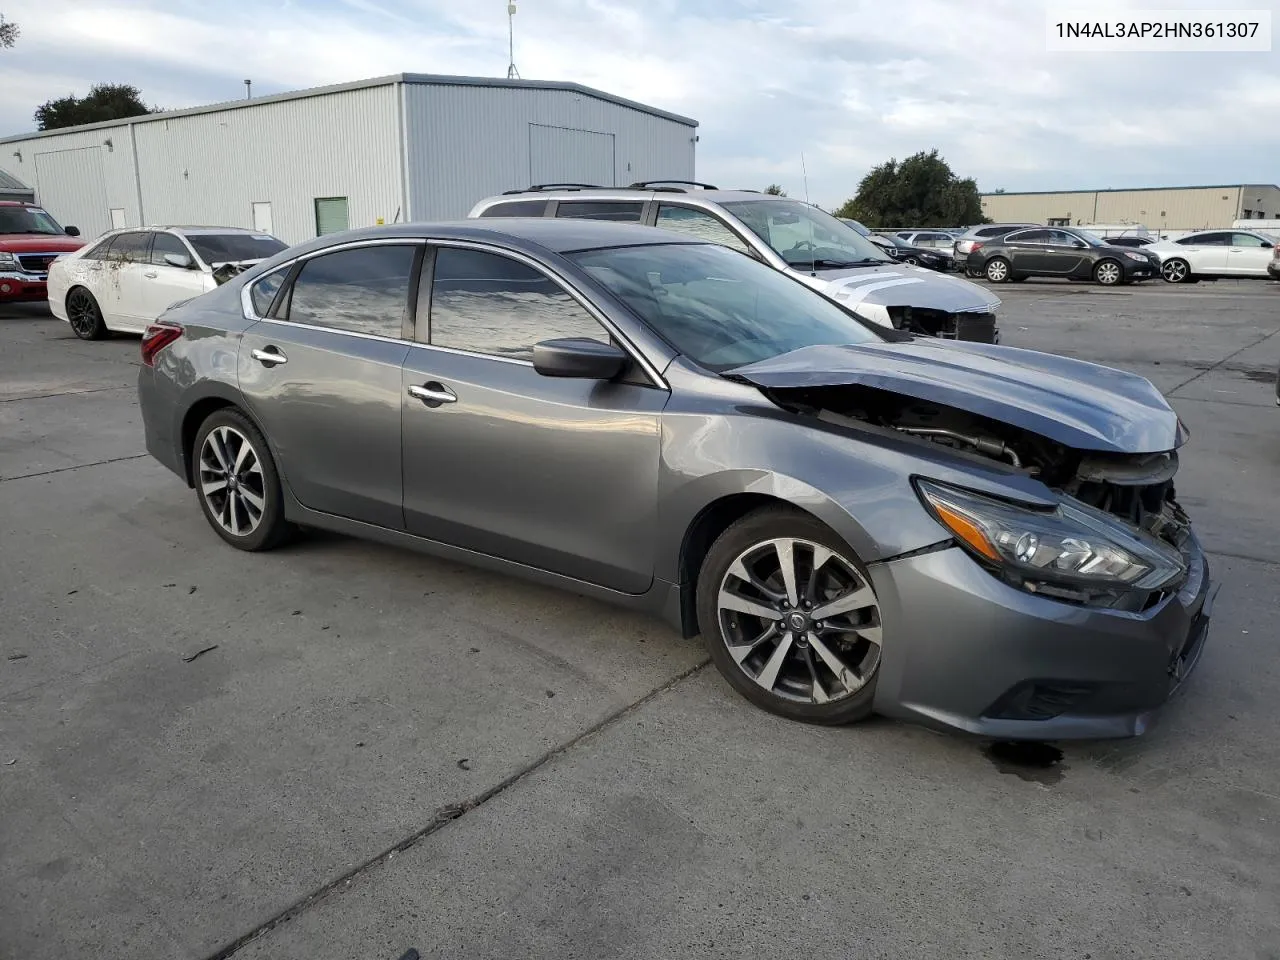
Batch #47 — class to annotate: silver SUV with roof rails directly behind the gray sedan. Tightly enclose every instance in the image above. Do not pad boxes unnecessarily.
[471,180,1000,343]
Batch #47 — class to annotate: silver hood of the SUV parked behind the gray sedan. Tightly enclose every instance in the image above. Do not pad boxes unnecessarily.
[795,264,1000,314]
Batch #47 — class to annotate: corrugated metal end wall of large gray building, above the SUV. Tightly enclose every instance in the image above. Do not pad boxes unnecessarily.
[404,83,698,220]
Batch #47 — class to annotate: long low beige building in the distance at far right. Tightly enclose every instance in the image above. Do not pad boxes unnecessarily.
[982,183,1280,230]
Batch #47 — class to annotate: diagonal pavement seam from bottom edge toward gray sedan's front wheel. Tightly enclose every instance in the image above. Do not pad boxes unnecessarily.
[205,657,710,960]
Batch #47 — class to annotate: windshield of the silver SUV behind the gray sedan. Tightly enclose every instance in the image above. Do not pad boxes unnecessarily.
[723,200,893,270]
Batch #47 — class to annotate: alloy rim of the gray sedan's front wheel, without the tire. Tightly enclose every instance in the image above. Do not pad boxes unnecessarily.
[717,538,881,704]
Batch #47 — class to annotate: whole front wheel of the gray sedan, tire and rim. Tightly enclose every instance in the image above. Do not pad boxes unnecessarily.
[698,507,881,724]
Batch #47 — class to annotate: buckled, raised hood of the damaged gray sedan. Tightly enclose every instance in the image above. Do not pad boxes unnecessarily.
[726,337,1187,453]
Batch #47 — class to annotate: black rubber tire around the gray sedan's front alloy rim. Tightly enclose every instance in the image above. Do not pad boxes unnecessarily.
[698,507,882,726]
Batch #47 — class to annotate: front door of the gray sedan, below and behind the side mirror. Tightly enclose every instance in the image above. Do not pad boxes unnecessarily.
[401,246,668,594]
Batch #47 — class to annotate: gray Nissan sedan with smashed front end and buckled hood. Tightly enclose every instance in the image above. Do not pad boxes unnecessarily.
[138,219,1213,739]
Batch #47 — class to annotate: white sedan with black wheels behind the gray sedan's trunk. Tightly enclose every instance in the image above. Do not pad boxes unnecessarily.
[49,227,288,340]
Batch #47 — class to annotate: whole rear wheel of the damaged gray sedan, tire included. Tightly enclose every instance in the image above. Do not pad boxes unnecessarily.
[192,407,292,550]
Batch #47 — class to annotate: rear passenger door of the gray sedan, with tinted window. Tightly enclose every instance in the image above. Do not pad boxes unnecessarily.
[238,243,421,530]
